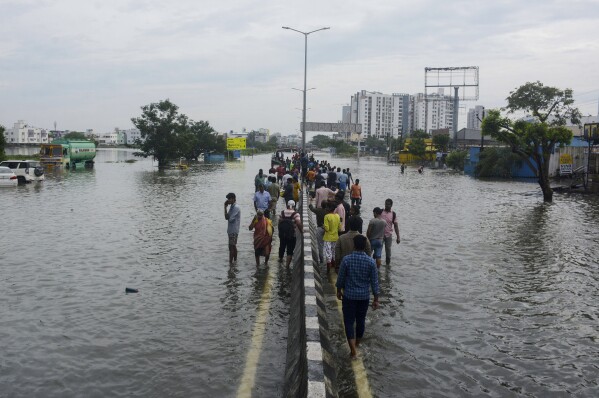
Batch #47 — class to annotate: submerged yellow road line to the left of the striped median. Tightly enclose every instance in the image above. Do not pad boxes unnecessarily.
[237,263,277,398]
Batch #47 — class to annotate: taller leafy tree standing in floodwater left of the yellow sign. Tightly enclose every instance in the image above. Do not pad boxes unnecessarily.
[131,99,189,169]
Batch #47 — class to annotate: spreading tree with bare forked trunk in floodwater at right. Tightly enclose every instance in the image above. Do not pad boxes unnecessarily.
[482,81,581,202]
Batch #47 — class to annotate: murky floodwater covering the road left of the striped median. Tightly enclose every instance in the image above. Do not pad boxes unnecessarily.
[0,150,289,397]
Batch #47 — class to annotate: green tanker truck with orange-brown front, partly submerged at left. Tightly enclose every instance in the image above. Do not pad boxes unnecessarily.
[40,139,96,169]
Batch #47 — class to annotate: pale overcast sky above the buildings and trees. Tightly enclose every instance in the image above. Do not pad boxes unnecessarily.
[0,0,599,134]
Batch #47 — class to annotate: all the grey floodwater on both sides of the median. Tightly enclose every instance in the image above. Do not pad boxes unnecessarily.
[0,149,599,397]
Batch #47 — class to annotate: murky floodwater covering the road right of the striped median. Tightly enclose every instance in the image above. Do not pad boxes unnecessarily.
[328,160,599,397]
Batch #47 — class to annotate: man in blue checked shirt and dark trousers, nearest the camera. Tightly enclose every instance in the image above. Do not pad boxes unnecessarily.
[336,235,379,359]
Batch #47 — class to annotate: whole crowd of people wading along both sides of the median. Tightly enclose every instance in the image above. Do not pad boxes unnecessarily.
[225,152,400,357]
